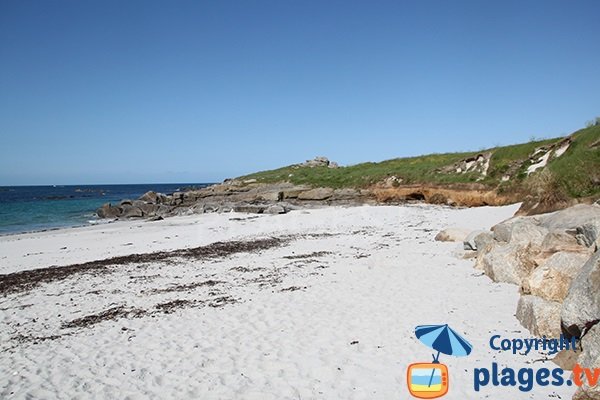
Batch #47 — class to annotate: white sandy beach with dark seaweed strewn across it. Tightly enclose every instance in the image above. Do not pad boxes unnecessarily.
[0,206,573,400]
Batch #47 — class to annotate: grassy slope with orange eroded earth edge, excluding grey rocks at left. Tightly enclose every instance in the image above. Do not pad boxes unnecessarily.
[237,125,600,212]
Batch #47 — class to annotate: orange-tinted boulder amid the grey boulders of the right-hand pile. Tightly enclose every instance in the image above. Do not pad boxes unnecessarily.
[526,252,588,302]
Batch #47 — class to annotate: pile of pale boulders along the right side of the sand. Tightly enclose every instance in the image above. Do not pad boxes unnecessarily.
[464,204,600,400]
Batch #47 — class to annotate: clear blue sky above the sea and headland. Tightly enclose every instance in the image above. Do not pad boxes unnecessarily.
[0,0,600,185]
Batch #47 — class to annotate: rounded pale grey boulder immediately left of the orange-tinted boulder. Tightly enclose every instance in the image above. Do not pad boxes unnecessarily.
[482,243,536,285]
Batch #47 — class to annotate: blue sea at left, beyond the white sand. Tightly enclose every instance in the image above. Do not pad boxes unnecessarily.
[0,183,210,235]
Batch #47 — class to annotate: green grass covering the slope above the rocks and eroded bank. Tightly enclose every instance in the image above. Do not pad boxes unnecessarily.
[239,126,600,197]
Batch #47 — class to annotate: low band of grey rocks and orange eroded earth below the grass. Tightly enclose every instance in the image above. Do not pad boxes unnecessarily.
[97,179,514,219]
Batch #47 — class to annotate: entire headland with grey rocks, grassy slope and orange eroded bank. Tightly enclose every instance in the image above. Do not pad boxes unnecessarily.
[98,122,600,218]
